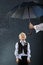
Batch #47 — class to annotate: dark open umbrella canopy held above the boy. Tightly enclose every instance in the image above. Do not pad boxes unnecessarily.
[8,2,43,19]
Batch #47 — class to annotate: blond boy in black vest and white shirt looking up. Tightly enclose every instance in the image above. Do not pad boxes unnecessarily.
[14,32,31,65]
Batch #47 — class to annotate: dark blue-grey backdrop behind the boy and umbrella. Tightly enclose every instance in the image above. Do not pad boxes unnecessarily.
[0,0,43,65]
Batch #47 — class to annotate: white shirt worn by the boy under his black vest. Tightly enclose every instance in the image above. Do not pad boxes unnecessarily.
[14,40,31,60]
